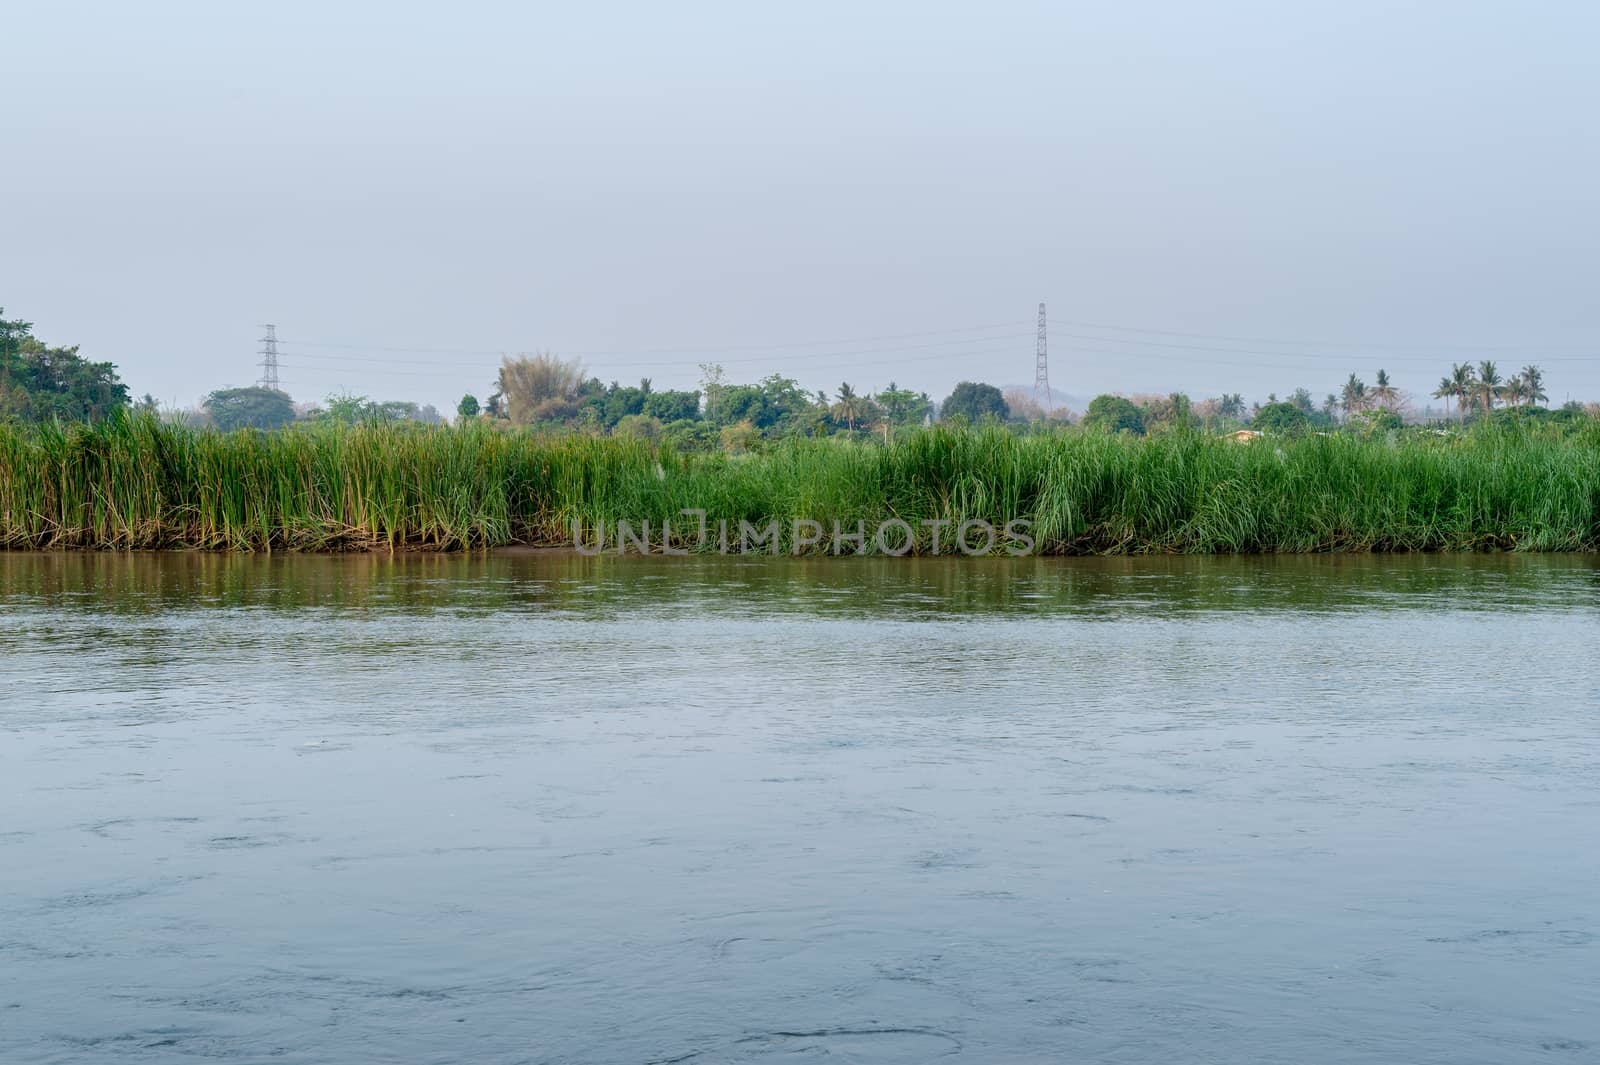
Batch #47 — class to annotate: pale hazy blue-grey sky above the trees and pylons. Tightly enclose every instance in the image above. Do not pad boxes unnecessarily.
[9,0,1600,406]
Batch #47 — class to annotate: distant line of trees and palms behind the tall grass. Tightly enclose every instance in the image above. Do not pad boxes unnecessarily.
[0,309,1600,438]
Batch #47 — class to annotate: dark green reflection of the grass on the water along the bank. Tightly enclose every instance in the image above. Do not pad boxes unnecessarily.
[0,552,1600,617]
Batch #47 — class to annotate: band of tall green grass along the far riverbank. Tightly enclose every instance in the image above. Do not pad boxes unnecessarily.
[0,417,1600,553]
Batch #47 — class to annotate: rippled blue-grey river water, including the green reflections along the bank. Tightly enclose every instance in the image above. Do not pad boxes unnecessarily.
[0,553,1600,1065]
